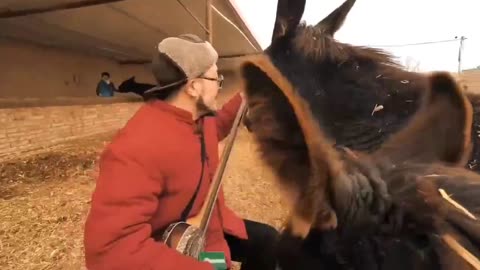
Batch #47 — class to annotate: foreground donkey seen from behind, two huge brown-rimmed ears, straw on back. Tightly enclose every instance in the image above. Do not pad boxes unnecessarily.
[241,45,480,270]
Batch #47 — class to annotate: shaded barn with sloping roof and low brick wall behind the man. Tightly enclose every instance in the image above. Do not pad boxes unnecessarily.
[0,0,261,158]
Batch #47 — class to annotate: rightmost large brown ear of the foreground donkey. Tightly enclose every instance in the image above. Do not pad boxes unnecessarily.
[374,72,473,166]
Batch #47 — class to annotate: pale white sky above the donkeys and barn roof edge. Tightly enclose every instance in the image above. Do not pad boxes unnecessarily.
[231,0,480,72]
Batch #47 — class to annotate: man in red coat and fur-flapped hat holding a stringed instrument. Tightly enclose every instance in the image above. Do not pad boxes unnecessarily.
[85,35,277,270]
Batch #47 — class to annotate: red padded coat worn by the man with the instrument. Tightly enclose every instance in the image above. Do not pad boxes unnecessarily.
[84,94,247,270]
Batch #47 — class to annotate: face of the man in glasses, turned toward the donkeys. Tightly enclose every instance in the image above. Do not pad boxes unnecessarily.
[196,64,220,111]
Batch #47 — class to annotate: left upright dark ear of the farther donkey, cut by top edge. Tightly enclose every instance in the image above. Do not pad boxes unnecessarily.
[272,0,306,43]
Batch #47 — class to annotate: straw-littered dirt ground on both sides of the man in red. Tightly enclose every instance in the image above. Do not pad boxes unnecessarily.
[0,128,286,270]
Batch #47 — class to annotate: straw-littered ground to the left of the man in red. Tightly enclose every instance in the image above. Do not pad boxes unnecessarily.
[0,134,111,269]
